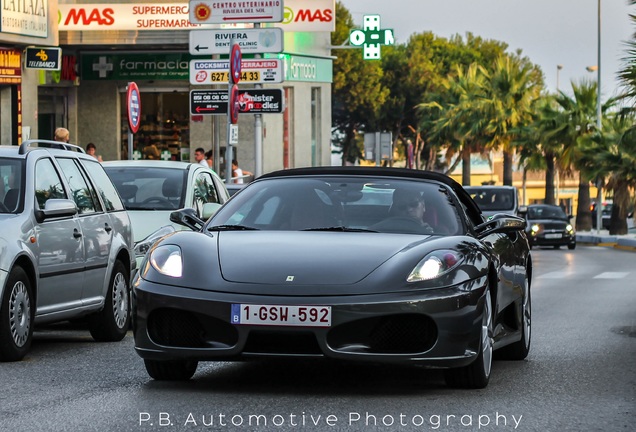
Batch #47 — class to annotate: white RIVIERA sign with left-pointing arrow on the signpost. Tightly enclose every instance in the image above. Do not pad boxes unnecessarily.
[189,27,284,55]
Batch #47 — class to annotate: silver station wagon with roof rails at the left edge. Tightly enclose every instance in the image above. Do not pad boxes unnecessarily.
[0,140,135,361]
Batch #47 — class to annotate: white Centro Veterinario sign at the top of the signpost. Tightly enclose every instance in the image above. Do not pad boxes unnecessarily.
[190,0,283,24]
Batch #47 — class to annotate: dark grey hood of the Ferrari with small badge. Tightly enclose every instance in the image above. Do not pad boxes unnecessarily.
[218,231,427,285]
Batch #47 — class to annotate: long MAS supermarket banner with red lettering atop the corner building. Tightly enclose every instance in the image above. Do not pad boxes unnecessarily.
[58,0,336,32]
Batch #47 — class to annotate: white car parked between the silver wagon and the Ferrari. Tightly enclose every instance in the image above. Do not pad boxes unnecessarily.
[102,160,230,265]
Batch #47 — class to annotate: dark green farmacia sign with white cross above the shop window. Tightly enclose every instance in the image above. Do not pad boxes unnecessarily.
[80,52,196,81]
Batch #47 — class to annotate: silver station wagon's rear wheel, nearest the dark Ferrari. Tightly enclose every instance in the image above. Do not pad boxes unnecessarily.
[88,261,130,342]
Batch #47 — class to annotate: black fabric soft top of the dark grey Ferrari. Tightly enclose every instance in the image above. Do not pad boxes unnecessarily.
[258,166,481,223]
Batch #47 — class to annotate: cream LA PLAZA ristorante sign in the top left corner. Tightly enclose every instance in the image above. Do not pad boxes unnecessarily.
[0,0,49,38]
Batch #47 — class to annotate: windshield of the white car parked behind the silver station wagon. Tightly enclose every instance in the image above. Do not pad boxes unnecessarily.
[104,166,187,210]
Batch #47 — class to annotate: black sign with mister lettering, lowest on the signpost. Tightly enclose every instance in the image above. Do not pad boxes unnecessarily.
[190,89,285,115]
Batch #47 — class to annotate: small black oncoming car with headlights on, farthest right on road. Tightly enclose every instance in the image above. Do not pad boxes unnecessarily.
[519,204,576,249]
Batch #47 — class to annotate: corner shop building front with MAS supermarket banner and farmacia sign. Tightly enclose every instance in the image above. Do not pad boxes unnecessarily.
[52,0,335,174]
